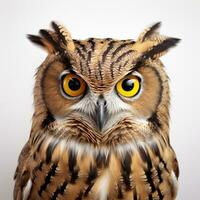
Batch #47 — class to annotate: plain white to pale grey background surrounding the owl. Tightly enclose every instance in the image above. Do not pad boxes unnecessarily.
[0,0,200,200]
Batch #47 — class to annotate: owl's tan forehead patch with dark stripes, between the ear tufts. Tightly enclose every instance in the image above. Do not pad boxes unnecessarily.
[73,38,136,90]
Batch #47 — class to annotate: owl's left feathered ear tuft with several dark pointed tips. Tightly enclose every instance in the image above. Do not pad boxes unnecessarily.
[27,22,75,54]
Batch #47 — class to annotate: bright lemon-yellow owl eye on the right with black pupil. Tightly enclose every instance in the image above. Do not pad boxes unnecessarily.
[116,75,141,97]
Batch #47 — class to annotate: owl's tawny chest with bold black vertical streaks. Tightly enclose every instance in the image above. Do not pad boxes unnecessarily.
[26,136,176,200]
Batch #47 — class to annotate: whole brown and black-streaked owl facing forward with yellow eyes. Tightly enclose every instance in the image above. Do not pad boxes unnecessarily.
[14,22,179,200]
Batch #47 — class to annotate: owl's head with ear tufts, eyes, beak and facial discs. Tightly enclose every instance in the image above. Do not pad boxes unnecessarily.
[28,22,179,145]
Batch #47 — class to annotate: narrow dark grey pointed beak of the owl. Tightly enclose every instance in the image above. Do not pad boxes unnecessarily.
[96,95,107,131]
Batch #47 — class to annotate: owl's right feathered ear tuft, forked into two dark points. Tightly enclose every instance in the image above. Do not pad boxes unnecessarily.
[133,22,180,59]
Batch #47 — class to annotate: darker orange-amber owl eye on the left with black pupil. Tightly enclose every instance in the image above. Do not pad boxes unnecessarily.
[61,73,86,97]
